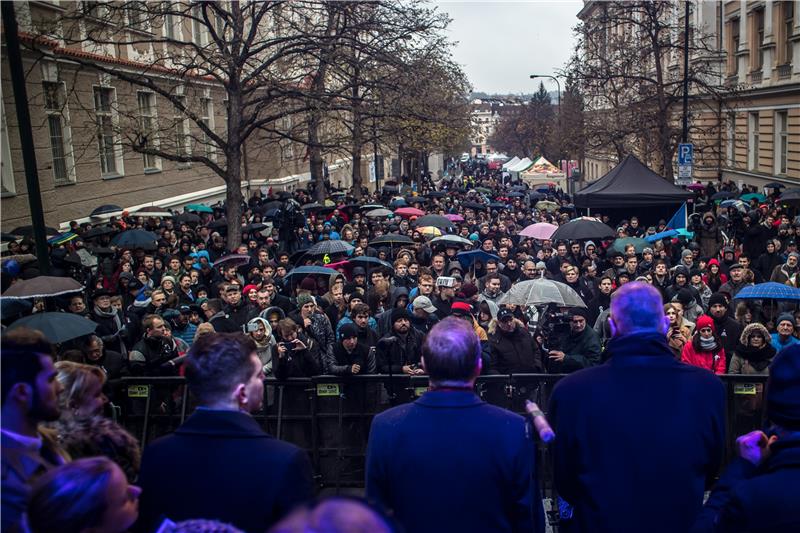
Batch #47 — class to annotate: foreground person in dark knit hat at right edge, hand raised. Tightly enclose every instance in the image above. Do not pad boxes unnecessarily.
[693,346,800,532]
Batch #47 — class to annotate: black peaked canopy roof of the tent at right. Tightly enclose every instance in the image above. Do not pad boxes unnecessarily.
[575,155,693,208]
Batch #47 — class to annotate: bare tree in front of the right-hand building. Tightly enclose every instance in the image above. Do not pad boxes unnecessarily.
[564,0,731,180]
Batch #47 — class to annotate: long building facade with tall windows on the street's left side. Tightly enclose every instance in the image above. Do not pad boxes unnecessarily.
[0,0,388,232]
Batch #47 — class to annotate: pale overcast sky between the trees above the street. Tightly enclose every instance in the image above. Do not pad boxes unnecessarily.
[436,0,583,94]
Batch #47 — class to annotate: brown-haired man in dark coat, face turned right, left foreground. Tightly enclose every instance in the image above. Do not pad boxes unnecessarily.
[137,334,313,531]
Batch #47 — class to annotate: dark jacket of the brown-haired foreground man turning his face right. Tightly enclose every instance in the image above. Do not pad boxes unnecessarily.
[136,408,313,532]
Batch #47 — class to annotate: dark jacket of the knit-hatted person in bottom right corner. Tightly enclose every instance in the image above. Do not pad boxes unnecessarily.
[692,434,800,533]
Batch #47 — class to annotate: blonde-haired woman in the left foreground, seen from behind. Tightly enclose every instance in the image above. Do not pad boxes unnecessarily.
[51,361,142,481]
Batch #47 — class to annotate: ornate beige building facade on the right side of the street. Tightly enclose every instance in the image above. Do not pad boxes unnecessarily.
[578,0,800,186]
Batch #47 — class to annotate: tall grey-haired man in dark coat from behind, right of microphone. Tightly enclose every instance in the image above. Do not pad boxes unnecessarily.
[548,282,725,533]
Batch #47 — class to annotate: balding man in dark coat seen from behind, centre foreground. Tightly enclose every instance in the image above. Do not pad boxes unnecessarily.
[366,317,544,533]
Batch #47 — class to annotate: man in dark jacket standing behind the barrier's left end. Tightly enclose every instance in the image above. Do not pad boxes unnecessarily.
[129,315,179,376]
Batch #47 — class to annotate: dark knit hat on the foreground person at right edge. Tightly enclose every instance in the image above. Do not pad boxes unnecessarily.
[767,345,800,430]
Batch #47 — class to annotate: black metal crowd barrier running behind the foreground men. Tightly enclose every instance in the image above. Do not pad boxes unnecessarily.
[111,374,767,520]
